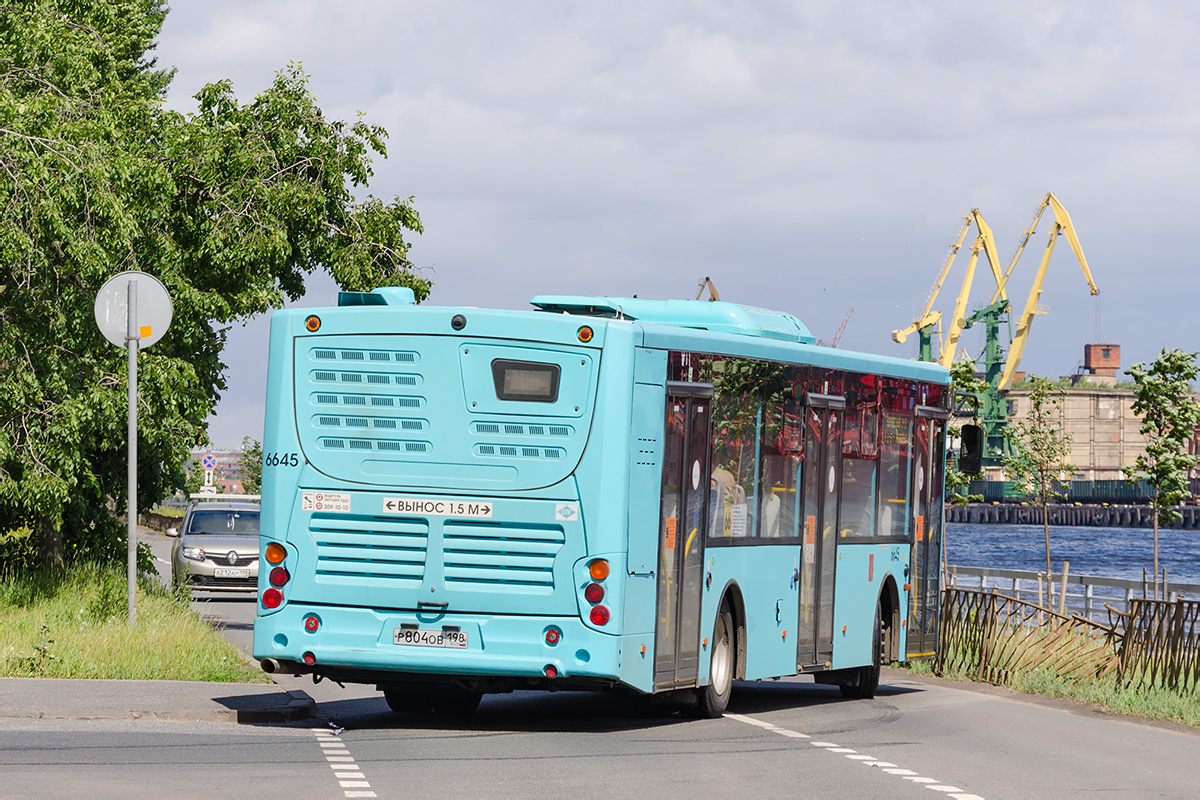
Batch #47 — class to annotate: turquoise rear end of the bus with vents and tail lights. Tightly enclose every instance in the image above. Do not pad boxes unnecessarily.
[254,289,631,708]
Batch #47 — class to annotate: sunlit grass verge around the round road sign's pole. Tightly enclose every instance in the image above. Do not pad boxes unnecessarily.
[0,564,270,684]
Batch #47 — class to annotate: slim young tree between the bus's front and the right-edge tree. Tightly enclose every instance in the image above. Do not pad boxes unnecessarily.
[1003,377,1075,581]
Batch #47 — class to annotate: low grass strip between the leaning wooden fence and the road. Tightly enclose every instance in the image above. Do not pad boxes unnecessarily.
[899,661,1200,728]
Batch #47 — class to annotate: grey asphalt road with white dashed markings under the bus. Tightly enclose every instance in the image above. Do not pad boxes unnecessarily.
[7,532,1200,799]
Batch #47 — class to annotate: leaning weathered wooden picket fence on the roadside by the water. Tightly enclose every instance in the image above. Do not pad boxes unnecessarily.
[937,588,1200,692]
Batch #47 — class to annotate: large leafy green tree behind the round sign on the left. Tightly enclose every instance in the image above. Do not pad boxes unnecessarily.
[0,0,430,566]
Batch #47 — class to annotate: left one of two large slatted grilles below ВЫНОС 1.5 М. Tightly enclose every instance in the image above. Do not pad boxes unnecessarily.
[308,515,430,587]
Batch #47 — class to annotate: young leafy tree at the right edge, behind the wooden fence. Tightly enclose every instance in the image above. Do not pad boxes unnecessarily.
[1122,348,1200,600]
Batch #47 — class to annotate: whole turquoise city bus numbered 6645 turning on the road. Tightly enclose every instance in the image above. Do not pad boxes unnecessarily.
[253,288,952,717]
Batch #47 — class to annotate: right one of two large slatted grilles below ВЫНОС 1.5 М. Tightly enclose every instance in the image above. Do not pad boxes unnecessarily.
[443,521,565,594]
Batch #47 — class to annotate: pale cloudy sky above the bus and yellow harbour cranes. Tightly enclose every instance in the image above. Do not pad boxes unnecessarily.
[156,0,1200,447]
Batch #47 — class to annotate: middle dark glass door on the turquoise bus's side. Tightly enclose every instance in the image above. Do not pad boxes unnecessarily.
[796,395,846,670]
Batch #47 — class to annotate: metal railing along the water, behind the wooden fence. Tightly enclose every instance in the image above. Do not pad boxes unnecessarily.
[946,566,1200,622]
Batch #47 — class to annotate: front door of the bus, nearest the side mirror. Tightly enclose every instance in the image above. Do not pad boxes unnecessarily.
[905,405,947,658]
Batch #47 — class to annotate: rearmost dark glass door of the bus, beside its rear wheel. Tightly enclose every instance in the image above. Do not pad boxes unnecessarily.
[654,381,713,688]
